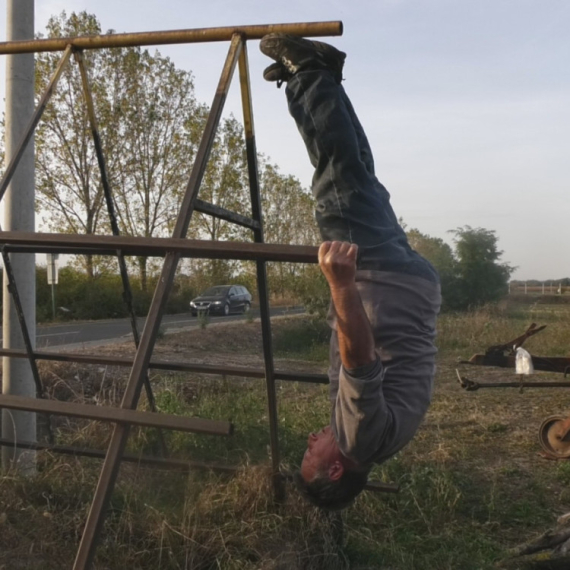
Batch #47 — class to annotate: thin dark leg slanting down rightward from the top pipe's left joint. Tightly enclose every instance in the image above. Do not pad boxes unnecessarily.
[75,51,167,455]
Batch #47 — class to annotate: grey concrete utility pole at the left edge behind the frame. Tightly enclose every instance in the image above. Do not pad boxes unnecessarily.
[2,0,36,474]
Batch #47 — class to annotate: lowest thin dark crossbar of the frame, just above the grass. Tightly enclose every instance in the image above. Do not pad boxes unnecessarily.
[0,439,239,474]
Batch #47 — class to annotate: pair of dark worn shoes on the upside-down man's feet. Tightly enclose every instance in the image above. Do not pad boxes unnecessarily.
[259,34,346,83]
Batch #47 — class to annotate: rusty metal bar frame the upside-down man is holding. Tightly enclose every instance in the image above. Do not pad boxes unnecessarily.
[0,21,396,570]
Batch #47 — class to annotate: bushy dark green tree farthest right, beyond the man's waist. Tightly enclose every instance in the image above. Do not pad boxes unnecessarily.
[450,226,515,308]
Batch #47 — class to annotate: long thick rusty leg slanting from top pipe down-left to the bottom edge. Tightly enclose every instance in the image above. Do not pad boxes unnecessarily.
[73,35,242,570]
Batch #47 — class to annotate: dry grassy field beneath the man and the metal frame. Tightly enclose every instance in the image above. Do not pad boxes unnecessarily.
[0,304,570,570]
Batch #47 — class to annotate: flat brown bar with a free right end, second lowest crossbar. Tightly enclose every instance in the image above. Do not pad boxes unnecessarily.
[0,394,233,435]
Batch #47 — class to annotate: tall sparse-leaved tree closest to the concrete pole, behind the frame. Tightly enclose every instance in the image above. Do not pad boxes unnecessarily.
[36,12,120,276]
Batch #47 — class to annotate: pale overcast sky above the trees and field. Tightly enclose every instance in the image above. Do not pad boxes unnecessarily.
[0,0,570,279]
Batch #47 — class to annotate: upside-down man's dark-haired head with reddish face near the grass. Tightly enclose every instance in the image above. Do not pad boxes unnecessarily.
[296,426,369,510]
